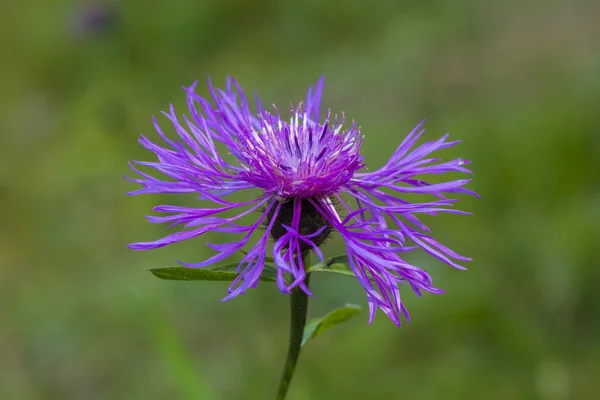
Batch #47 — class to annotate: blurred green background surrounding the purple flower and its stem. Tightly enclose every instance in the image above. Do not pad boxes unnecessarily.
[0,0,600,400]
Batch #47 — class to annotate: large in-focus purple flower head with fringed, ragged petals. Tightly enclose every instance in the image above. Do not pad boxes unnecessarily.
[129,78,476,325]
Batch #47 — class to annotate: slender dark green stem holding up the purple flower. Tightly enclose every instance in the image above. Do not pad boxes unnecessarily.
[276,252,310,400]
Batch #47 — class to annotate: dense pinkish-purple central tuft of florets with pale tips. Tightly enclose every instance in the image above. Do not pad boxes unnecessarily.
[238,105,364,198]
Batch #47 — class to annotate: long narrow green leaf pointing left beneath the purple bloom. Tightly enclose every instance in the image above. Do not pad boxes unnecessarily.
[150,263,277,282]
